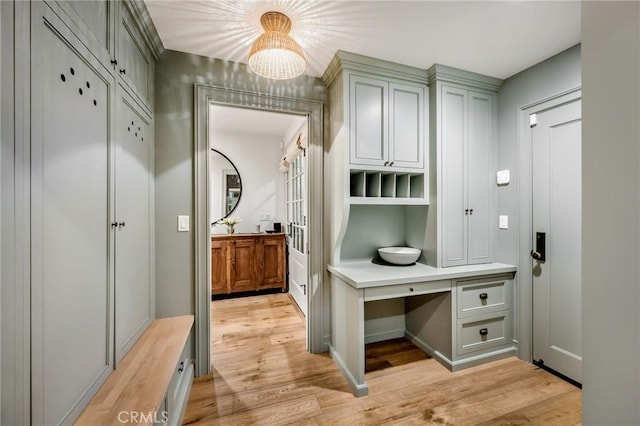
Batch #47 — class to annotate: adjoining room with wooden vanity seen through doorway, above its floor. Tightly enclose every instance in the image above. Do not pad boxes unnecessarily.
[208,105,309,314]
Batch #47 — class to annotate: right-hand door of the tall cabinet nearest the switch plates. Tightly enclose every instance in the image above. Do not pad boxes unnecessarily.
[467,91,496,264]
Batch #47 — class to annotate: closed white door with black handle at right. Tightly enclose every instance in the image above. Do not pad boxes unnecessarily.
[531,99,582,382]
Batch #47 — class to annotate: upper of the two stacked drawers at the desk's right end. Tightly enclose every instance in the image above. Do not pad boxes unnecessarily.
[457,277,511,318]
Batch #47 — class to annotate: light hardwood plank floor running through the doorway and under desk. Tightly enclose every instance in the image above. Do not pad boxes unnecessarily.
[184,294,581,426]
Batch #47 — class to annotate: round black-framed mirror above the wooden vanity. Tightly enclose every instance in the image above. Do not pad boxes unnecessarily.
[209,148,242,225]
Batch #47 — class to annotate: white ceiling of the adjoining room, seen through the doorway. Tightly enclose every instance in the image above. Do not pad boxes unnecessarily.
[209,105,306,138]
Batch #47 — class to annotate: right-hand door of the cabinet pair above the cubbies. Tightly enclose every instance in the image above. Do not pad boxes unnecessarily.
[388,83,425,169]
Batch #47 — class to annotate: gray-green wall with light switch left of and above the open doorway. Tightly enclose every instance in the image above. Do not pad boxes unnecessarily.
[155,51,326,317]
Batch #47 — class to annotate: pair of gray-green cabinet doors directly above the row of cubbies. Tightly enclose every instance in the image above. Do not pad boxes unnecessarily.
[349,74,425,169]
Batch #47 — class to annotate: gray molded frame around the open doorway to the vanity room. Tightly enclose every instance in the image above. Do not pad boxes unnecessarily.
[193,84,324,376]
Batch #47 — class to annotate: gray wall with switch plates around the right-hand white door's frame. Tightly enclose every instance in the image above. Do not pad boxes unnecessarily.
[496,45,581,360]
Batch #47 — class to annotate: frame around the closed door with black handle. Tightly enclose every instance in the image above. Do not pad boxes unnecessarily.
[513,87,582,362]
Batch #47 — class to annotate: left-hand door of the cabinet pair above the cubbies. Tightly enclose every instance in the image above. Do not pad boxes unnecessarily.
[349,75,389,166]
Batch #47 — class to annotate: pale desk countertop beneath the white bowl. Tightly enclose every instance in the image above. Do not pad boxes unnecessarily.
[327,261,516,288]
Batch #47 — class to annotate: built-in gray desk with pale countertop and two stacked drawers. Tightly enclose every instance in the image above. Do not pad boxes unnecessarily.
[328,261,516,396]
